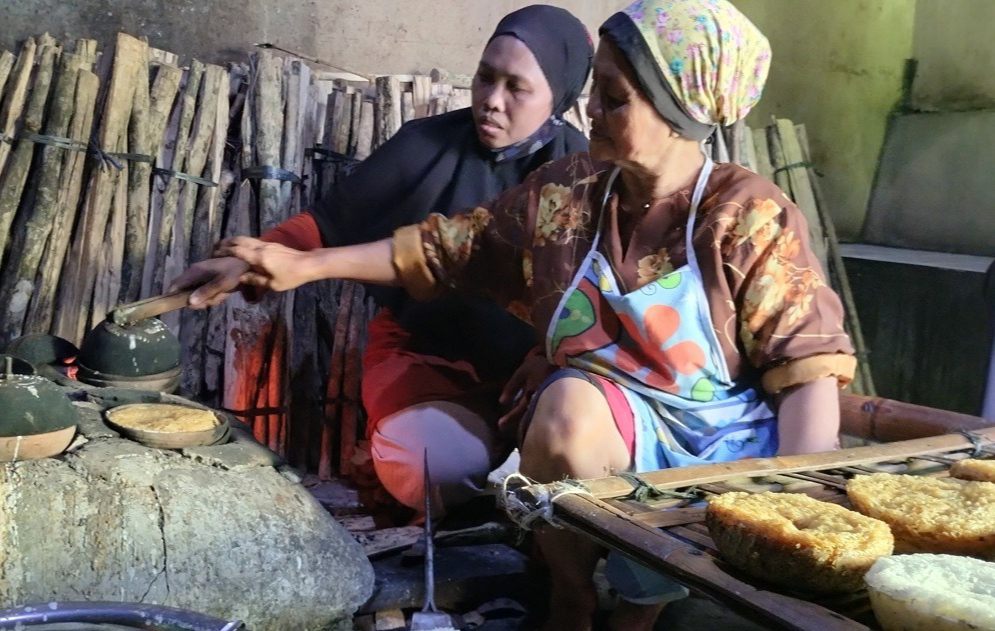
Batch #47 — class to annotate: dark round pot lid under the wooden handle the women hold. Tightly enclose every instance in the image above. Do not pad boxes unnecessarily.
[79,318,180,377]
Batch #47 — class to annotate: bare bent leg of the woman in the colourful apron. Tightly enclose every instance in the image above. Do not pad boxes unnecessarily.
[521,377,630,631]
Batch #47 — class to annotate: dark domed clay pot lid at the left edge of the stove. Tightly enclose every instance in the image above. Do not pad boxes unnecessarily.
[0,357,79,437]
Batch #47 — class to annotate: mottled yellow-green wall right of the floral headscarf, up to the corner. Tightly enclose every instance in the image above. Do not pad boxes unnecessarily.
[735,0,916,239]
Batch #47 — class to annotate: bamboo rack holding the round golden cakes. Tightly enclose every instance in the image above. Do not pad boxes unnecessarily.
[511,396,995,631]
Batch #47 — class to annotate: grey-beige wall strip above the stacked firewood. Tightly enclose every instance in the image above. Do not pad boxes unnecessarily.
[0,0,627,73]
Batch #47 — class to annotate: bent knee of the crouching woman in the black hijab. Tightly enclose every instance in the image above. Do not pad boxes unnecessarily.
[371,401,500,514]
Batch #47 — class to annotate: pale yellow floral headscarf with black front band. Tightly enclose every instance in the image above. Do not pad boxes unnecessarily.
[601,0,770,140]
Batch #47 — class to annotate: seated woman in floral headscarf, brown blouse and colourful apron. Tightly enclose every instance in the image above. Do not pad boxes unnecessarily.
[216,0,855,629]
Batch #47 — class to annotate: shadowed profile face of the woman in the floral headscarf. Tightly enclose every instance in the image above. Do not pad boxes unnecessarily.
[587,39,675,167]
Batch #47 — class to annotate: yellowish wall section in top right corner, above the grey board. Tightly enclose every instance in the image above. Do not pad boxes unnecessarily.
[913,0,995,111]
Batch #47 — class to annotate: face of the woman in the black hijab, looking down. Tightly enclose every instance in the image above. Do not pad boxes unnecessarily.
[473,35,553,149]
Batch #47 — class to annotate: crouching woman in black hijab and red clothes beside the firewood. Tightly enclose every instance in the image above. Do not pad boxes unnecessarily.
[175,5,593,509]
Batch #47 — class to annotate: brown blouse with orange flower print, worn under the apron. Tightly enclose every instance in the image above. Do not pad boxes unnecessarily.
[394,153,856,393]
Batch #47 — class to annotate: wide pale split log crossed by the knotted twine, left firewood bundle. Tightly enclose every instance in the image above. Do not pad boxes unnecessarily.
[56,33,148,342]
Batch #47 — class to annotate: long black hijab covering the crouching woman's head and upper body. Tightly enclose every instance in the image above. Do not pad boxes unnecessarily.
[312,5,594,379]
